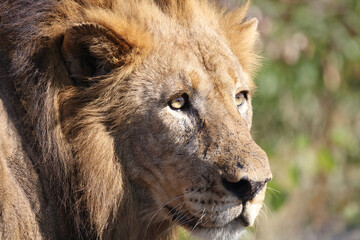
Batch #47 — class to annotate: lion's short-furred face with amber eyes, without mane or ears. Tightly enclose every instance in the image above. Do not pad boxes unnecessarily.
[122,24,271,239]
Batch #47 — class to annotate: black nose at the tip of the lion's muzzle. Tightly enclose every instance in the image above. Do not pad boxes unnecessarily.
[222,176,270,202]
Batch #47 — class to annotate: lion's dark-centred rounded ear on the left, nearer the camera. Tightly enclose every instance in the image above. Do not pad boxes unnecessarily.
[61,23,134,86]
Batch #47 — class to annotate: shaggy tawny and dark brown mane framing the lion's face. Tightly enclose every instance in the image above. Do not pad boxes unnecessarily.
[0,0,258,239]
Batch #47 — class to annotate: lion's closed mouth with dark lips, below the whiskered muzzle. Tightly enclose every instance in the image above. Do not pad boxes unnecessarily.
[164,205,250,230]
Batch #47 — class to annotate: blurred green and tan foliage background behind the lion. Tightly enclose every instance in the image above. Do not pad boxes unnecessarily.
[180,0,360,240]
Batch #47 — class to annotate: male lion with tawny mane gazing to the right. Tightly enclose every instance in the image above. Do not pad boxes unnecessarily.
[0,0,272,240]
